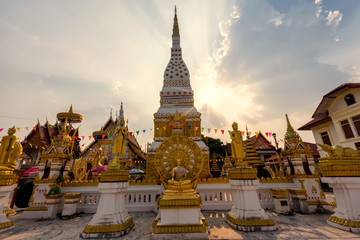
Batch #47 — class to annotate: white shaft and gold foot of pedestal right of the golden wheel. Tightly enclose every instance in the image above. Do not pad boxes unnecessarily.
[226,179,276,232]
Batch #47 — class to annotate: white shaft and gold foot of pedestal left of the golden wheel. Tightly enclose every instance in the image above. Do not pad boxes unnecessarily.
[80,182,133,238]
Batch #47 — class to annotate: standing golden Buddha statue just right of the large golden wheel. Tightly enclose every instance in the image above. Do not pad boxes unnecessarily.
[230,122,244,167]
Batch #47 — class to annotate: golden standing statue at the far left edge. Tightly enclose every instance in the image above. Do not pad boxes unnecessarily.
[0,126,22,170]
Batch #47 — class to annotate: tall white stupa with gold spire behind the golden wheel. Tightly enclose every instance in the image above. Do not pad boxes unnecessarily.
[147,7,210,180]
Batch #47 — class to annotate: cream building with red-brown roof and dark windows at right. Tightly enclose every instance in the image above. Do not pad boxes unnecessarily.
[299,83,360,157]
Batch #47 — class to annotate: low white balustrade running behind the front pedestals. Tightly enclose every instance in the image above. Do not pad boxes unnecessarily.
[62,179,293,213]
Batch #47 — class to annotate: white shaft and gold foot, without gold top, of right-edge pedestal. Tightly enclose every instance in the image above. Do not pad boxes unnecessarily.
[321,177,360,233]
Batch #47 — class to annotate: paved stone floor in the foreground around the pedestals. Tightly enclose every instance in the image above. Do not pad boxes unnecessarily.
[0,211,360,240]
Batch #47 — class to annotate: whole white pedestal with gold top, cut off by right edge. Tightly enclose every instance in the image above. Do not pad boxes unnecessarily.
[319,154,360,233]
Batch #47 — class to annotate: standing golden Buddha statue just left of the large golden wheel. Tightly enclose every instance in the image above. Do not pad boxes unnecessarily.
[109,118,127,169]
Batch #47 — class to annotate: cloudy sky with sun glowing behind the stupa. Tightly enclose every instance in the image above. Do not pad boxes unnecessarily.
[0,0,360,149]
